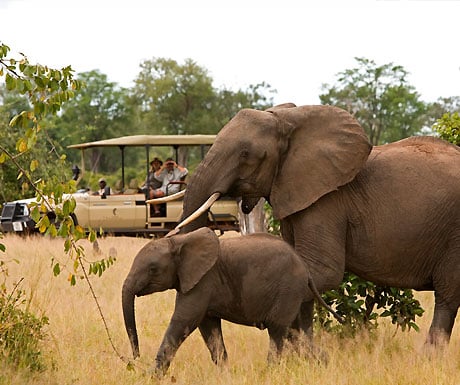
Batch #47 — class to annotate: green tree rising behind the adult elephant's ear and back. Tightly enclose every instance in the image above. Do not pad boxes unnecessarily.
[319,58,427,145]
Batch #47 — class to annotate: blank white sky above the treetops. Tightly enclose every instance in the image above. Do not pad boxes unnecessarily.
[0,0,460,105]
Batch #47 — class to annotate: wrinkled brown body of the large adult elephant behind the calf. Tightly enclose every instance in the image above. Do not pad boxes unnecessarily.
[182,104,460,344]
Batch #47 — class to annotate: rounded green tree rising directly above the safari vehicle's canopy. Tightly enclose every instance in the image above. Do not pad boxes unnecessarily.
[130,58,275,165]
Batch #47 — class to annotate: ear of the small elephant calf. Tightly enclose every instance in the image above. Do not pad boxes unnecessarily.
[170,227,220,293]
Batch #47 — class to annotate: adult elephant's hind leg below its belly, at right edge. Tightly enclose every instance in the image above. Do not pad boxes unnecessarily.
[426,293,458,346]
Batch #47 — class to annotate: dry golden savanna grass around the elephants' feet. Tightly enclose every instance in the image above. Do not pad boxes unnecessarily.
[0,235,460,385]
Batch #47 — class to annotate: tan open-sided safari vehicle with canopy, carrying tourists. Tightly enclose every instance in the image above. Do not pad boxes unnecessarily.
[0,135,239,236]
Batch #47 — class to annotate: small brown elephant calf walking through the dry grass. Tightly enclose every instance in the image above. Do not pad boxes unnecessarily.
[122,228,324,375]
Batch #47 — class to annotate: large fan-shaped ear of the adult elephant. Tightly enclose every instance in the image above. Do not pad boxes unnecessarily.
[270,106,372,219]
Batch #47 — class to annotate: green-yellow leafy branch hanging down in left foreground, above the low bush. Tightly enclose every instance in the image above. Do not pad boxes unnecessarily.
[0,44,113,284]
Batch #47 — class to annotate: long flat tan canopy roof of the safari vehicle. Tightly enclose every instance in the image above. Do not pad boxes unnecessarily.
[67,134,216,150]
